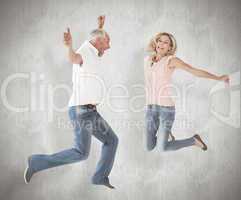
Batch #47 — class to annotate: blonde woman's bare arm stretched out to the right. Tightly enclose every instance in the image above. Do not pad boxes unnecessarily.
[169,57,229,83]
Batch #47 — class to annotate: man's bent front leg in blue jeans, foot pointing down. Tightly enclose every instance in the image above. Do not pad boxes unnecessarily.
[92,113,118,188]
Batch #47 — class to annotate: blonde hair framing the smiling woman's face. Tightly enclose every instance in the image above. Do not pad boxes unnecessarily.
[147,32,177,55]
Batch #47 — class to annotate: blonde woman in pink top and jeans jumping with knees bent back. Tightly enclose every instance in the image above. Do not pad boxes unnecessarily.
[144,32,229,151]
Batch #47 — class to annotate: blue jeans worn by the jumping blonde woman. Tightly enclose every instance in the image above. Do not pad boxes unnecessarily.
[145,105,195,151]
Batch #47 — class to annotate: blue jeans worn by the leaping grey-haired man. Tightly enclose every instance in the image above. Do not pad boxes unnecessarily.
[30,106,118,184]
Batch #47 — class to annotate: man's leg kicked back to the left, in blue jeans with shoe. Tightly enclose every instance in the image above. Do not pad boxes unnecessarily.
[25,108,93,183]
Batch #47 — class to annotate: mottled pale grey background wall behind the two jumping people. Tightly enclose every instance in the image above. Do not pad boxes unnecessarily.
[0,0,241,200]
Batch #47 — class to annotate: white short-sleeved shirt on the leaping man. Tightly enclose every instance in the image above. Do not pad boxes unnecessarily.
[68,41,105,107]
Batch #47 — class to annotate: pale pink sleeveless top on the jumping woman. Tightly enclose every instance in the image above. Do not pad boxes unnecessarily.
[144,56,175,106]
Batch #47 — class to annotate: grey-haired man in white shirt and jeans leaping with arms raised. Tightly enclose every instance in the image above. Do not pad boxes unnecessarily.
[24,16,118,189]
